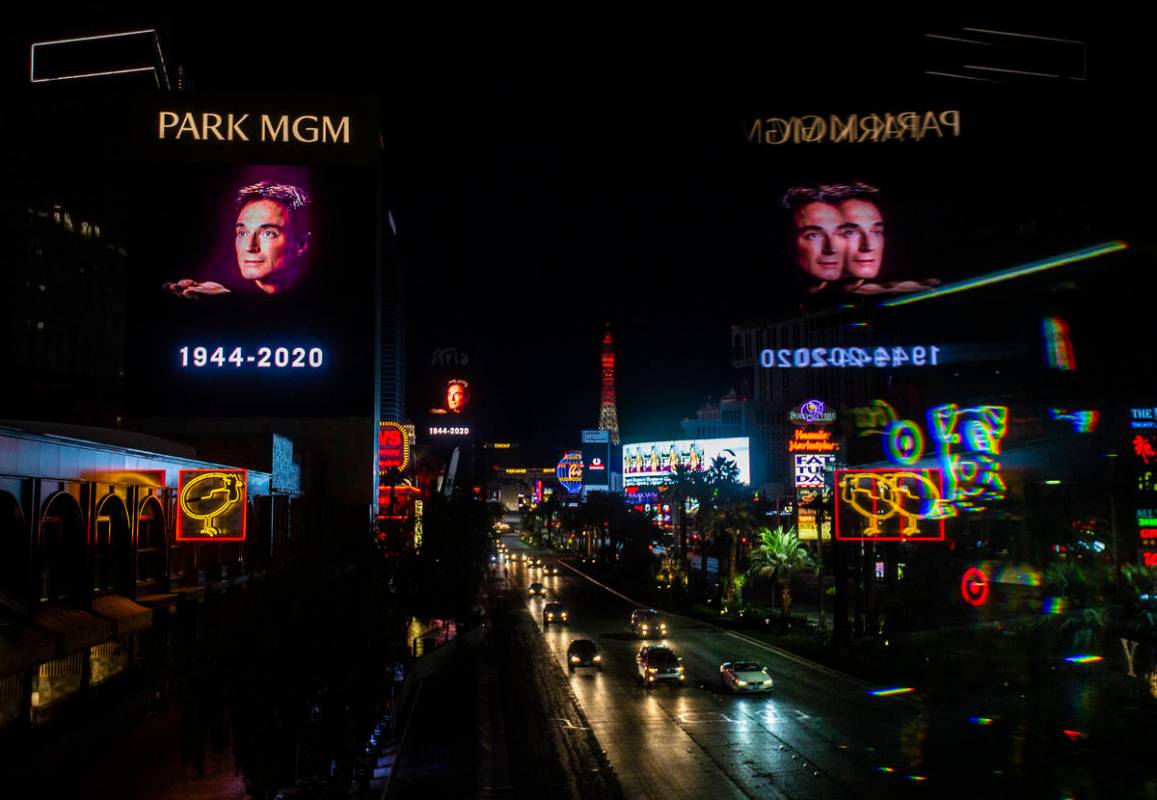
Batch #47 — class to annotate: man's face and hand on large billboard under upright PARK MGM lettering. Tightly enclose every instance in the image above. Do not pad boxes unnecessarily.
[163,181,312,300]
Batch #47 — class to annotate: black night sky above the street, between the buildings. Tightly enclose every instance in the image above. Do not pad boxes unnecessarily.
[5,12,1123,461]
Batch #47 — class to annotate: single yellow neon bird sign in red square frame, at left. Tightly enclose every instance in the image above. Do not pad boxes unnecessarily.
[177,469,249,542]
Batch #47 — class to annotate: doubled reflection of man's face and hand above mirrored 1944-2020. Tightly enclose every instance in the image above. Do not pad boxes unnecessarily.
[782,181,939,294]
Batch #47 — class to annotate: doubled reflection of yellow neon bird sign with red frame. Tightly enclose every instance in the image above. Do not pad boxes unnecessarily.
[835,469,956,542]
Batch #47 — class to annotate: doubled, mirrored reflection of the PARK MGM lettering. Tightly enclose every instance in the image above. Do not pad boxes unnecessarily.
[747,109,960,145]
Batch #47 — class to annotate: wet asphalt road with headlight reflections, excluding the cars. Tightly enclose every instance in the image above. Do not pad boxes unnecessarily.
[507,537,1157,800]
